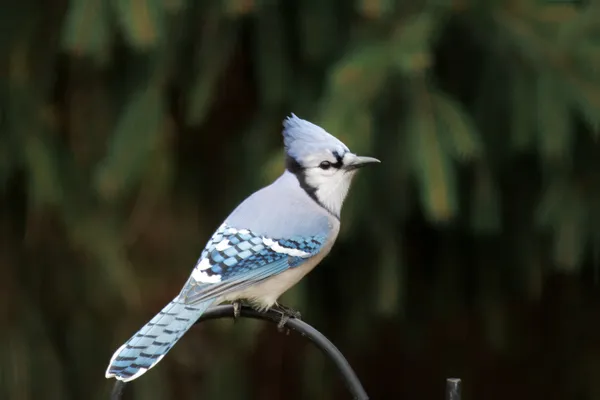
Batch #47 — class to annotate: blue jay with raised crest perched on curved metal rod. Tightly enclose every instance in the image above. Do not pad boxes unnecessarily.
[105,113,380,382]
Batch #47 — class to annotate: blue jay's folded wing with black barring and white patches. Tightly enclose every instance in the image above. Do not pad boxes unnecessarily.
[180,224,327,304]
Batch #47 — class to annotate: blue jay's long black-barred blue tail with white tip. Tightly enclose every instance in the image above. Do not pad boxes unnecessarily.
[106,298,214,382]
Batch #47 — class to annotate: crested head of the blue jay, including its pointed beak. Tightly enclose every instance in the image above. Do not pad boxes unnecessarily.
[283,114,380,217]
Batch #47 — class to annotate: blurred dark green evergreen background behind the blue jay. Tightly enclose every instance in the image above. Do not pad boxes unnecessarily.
[0,0,600,400]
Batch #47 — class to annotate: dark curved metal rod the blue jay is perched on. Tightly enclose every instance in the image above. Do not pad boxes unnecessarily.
[111,305,369,400]
